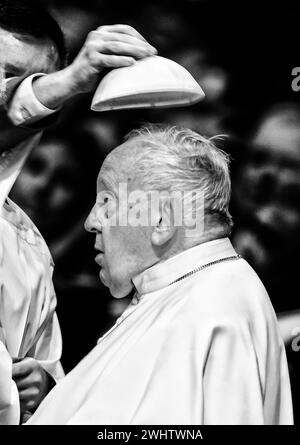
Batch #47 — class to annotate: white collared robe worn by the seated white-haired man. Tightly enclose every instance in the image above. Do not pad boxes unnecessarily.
[28,238,293,425]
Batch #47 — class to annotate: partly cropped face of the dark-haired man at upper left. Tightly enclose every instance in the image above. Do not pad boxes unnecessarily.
[0,27,58,84]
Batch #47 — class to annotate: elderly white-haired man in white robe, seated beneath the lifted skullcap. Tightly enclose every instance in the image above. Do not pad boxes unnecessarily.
[29,127,293,425]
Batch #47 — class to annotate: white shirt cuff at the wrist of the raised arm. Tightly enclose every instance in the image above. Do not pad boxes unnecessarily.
[8,73,57,126]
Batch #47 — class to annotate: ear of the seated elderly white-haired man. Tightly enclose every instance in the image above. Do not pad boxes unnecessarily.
[151,197,176,246]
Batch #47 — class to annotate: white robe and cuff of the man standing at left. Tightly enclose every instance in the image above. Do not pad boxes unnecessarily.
[0,76,64,425]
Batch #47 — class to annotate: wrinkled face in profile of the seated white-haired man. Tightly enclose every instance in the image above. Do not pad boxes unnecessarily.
[85,141,153,298]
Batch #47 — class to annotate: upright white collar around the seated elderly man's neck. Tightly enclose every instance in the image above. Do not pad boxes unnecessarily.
[132,238,236,295]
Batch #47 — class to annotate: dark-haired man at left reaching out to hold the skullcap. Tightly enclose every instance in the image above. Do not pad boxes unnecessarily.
[0,0,156,424]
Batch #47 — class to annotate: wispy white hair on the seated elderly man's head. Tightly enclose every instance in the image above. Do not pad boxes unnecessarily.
[126,125,233,234]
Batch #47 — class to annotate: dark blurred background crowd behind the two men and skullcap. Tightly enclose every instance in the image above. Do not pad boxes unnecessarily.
[8,0,300,421]
